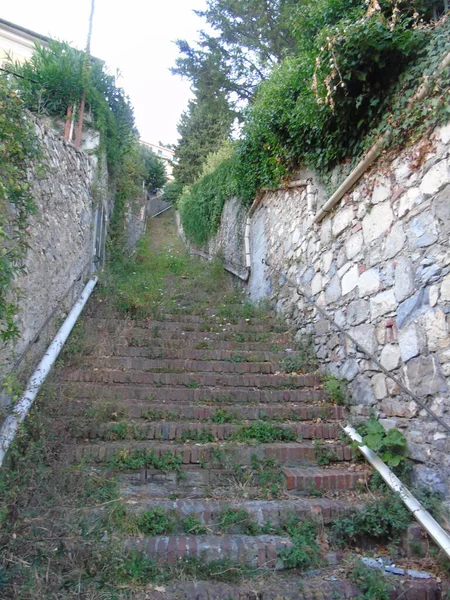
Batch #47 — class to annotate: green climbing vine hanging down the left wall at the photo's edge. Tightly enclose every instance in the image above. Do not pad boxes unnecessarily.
[0,75,41,342]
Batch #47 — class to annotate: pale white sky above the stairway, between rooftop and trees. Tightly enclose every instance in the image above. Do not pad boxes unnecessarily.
[0,0,205,143]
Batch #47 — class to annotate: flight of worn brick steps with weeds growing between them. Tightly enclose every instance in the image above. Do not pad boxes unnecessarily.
[30,213,440,600]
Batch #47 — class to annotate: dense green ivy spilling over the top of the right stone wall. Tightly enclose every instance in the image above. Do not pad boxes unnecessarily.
[178,0,450,244]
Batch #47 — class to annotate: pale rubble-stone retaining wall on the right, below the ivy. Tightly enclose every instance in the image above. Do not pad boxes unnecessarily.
[181,125,450,495]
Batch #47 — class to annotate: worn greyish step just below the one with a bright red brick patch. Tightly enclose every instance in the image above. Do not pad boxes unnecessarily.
[122,493,363,533]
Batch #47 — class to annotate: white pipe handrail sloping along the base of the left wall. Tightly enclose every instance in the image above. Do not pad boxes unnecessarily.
[0,277,98,466]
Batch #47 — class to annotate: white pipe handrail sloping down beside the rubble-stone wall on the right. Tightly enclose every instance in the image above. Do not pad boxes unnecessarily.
[344,425,450,558]
